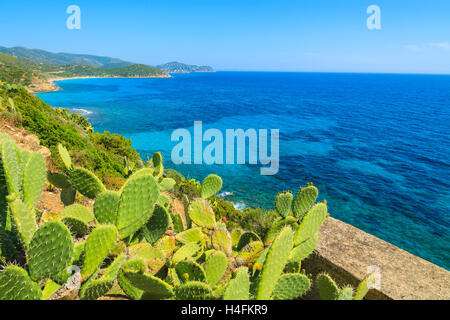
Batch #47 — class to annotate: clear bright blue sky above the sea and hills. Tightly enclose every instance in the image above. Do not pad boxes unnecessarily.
[0,0,450,73]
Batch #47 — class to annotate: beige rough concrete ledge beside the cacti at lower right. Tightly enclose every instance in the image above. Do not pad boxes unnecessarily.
[302,217,450,300]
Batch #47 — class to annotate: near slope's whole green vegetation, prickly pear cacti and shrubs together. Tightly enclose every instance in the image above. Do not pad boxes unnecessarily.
[0,79,373,300]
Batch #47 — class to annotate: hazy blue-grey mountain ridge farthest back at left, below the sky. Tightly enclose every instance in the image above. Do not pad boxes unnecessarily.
[0,46,133,68]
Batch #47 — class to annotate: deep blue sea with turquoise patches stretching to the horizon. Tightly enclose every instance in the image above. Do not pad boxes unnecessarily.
[39,72,450,269]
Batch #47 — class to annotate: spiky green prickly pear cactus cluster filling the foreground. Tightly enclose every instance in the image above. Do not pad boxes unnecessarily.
[0,136,373,300]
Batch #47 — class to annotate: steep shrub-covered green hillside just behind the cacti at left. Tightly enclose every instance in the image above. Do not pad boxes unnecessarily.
[0,83,141,188]
